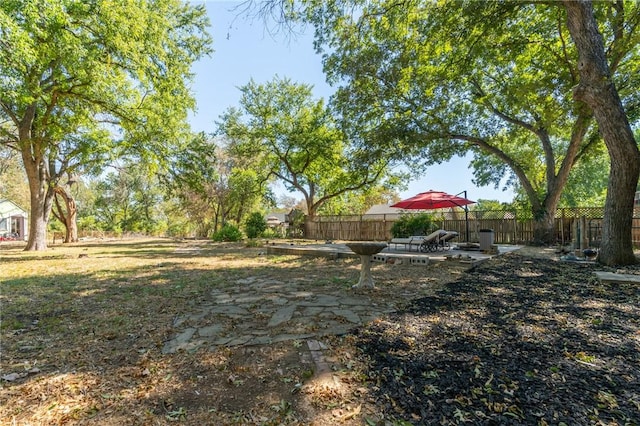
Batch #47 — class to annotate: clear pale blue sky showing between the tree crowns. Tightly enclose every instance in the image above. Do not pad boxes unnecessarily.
[190,1,513,202]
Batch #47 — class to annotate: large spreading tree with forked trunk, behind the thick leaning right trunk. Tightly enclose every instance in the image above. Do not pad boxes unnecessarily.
[311,0,639,243]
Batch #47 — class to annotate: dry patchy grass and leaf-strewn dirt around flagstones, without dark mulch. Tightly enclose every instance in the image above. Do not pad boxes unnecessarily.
[0,239,476,425]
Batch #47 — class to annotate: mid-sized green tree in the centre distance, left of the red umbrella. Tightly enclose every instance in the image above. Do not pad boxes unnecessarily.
[219,77,402,216]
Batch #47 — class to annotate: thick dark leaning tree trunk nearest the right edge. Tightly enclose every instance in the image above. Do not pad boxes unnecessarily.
[564,0,640,265]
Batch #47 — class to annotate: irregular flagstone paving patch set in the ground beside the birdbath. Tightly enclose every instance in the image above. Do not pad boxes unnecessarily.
[162,276,392,353]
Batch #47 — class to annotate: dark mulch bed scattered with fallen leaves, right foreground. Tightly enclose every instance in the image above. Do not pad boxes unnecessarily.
[357,254,640,425]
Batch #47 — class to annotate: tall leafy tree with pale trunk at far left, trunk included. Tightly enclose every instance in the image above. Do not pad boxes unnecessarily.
[0,0,210,250]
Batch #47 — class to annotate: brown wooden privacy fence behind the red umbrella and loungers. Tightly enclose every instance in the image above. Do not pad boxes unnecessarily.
[304,207,640,247]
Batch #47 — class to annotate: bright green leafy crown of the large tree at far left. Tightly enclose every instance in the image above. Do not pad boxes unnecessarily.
[0,0,210,156]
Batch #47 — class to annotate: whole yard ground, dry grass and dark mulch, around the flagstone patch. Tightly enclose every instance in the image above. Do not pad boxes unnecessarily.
[0,241,640,425]
